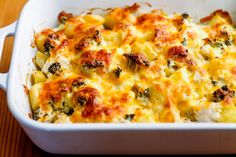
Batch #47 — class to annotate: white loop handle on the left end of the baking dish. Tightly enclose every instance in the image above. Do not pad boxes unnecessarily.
[0,21,17,91]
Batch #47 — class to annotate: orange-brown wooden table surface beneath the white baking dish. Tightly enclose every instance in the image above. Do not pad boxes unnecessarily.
[0,0,54,157]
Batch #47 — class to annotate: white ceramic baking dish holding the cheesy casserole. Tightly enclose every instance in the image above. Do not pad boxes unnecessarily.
[0,0,236,154]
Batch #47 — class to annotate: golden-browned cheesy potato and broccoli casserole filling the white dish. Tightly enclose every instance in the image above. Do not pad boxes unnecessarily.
[29,3,236,123]
